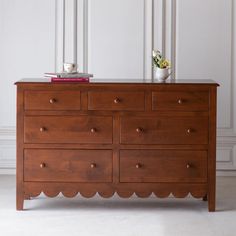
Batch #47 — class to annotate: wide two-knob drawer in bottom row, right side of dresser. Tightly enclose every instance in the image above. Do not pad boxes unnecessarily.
[120,150,207,183]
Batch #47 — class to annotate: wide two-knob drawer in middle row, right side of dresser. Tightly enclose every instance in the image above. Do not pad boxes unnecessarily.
[120,117,208,144]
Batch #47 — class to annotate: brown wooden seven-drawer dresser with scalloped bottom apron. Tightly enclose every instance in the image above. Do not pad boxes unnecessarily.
[16,79,217,211]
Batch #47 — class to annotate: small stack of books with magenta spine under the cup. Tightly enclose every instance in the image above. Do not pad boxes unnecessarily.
[44,72,93,82]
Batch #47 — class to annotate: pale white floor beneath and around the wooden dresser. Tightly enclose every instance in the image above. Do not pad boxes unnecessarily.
[0,175,236,236]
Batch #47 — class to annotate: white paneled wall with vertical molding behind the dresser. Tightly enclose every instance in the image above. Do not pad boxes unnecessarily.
[0,0,236,175]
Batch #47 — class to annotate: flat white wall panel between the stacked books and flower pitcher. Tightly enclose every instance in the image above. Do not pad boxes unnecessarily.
[84,0,148,79]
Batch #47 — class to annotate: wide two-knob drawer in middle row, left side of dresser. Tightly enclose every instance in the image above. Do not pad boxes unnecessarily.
[24,116,112,143]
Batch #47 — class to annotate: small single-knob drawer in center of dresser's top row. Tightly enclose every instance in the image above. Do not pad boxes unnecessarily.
[88,91,145,111]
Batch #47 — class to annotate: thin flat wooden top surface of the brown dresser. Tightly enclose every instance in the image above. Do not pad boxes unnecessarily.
[15,78,219,86]
